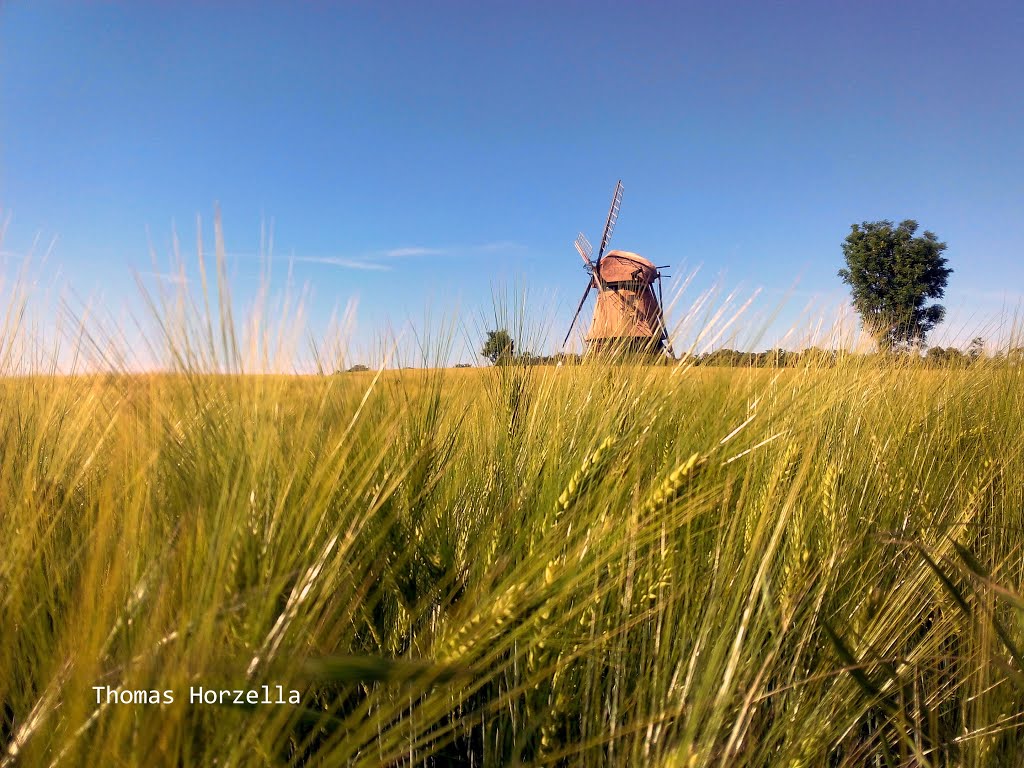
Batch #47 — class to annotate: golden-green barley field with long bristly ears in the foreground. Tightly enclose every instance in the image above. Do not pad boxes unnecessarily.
[0,286,1024,768]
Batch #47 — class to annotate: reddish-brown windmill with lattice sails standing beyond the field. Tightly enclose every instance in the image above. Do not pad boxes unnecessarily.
[562,181,672,355]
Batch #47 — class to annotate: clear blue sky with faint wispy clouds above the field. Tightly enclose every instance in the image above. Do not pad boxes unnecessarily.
[0,1,1024,364]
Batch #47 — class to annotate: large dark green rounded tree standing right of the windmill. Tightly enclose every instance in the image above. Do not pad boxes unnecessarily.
[839,219,952,350]
